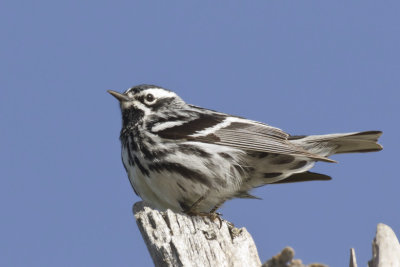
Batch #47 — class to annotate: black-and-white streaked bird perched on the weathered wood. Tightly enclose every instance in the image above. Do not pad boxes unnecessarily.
[109,85,382,213]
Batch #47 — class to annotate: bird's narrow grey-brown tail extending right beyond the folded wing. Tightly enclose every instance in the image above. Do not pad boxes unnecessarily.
[289,131,382,157]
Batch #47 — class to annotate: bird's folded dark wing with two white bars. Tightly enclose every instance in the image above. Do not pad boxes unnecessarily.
[152,109,334,162]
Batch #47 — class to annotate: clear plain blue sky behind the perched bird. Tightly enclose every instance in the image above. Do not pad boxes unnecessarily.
[0,0,400,266]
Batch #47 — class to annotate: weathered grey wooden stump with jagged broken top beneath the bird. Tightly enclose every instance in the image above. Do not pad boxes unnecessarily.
[133,202,400,267]
